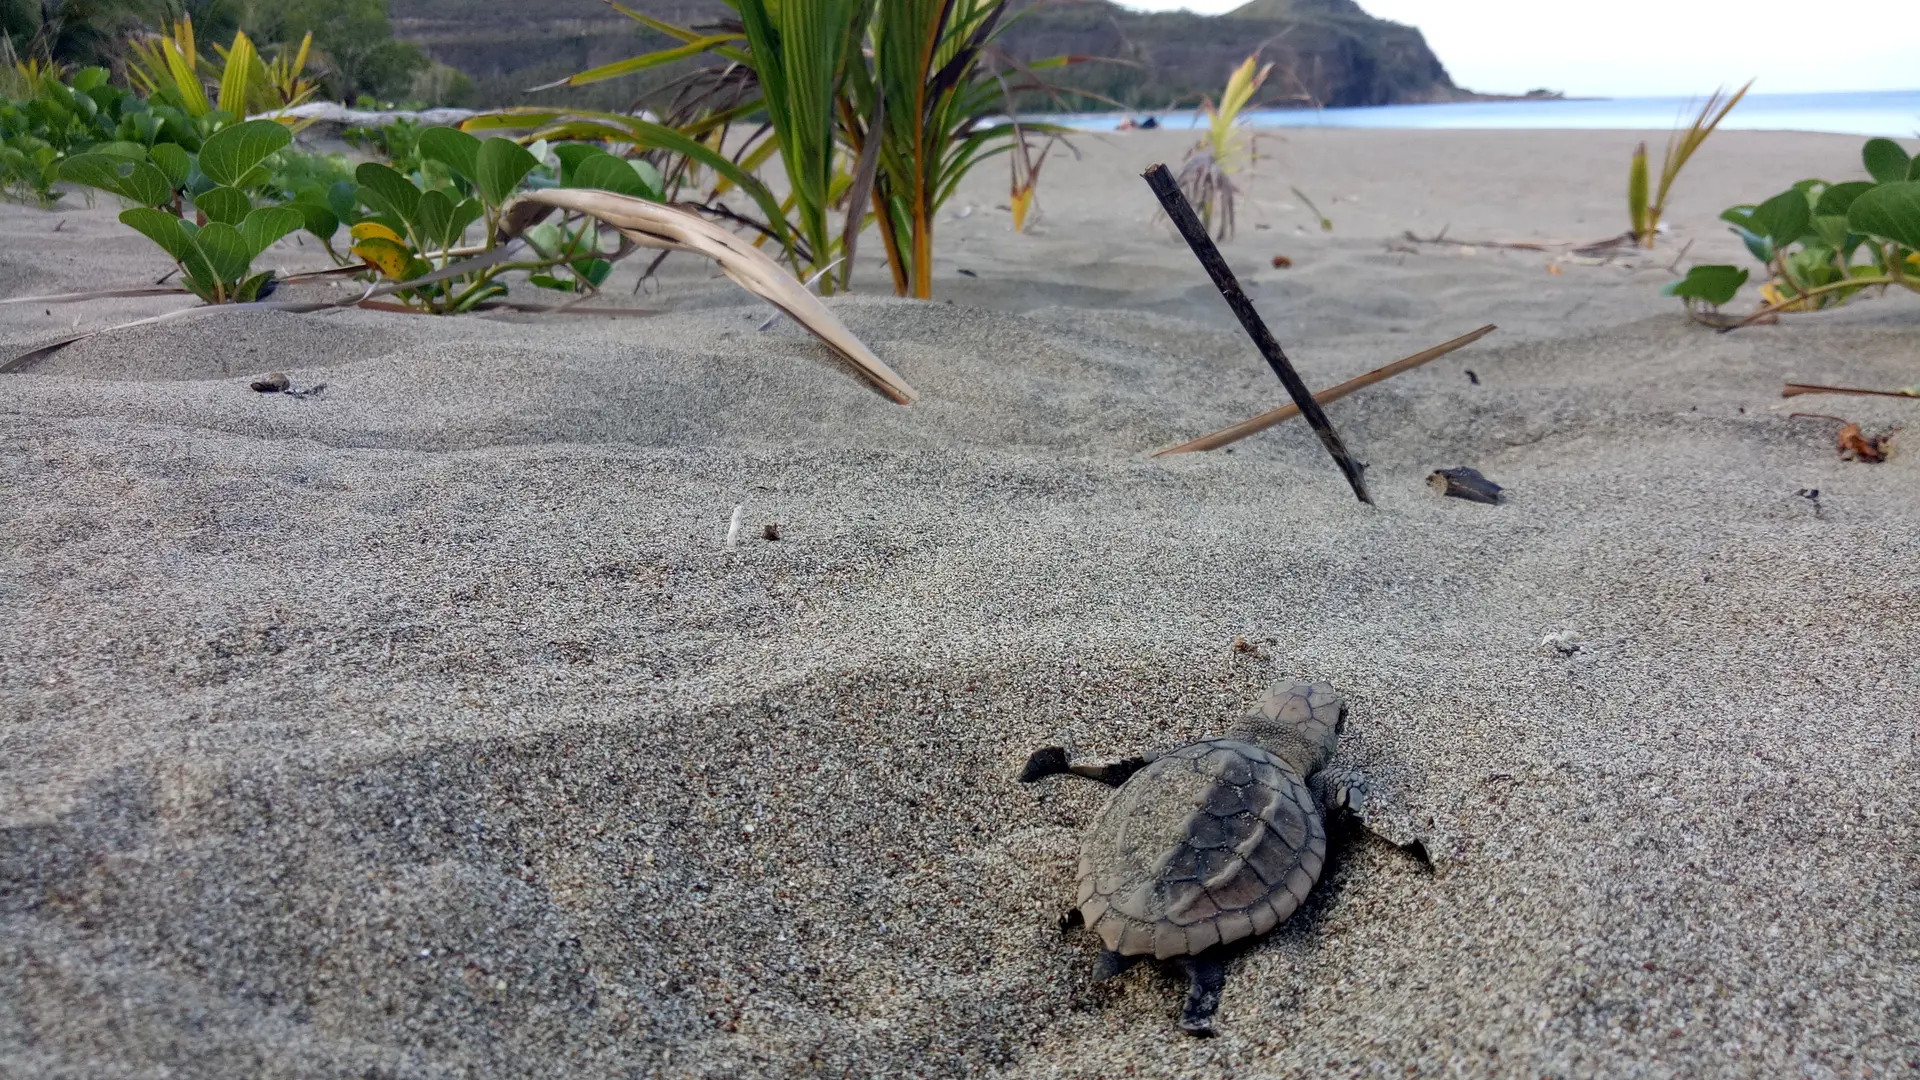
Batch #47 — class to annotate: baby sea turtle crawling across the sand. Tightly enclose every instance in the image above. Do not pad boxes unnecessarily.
[1020,682,1348,1036]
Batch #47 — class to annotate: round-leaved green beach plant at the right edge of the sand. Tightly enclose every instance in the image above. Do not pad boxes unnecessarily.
[1665,138,1920,323]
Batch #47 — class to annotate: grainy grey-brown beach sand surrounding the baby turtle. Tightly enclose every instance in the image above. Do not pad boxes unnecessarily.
[0,131,1920,1078]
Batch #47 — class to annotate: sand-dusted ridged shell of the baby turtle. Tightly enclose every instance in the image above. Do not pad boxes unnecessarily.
[1079,738,1327,959]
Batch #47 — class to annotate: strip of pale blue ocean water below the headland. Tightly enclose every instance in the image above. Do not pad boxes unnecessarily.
[1048,90,1920,138]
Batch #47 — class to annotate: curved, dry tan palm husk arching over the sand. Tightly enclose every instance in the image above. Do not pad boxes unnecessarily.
[507,188,920,405]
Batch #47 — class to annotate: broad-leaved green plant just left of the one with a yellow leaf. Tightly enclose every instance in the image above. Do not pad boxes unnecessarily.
[60,119,301,304]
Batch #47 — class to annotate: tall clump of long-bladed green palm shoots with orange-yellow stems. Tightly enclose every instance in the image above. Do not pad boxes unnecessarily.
[467,0,1071,298]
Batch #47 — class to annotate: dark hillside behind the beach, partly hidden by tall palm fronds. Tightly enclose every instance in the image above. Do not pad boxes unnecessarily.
[392,0,1465,110]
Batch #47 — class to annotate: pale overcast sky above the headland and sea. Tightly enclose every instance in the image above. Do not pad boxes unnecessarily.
[1121,0,1920,96]
